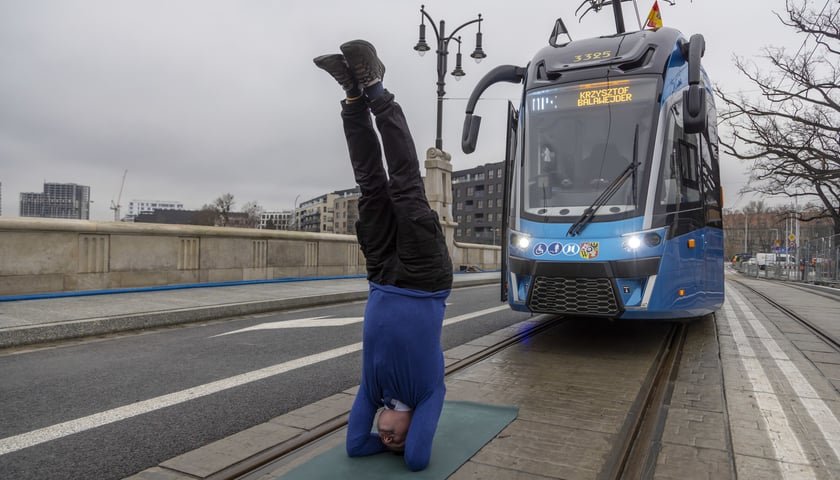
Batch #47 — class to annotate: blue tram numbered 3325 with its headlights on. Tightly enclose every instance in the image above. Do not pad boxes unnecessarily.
[462,7,724,319]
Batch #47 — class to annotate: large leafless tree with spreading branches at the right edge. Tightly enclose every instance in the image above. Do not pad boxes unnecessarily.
[715,0,840,233]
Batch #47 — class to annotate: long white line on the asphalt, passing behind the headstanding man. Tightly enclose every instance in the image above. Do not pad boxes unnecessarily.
[0,305,508,456]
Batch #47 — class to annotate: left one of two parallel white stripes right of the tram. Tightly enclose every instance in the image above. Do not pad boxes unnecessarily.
[723,298,816,479]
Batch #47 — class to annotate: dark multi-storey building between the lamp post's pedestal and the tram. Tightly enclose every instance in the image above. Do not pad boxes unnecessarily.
[452,162,504,245]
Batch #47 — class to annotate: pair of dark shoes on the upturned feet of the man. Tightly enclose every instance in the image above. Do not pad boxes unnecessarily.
[313,40,385,91]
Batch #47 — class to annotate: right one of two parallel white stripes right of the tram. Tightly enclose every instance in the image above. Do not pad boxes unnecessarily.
[733,293,840,460]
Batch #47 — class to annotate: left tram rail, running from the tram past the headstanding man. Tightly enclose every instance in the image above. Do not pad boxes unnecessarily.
[207,315,568,480]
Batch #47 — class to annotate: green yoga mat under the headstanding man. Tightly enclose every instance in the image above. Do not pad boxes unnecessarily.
[277,402,519,480]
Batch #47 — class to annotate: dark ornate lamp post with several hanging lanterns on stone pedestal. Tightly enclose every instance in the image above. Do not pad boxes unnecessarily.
[414,5,487,150]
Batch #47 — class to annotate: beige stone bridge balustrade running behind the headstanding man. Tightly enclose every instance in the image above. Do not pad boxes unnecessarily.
[0,218,500,296]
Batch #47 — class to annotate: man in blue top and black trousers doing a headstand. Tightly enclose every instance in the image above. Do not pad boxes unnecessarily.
[314,40,452,471]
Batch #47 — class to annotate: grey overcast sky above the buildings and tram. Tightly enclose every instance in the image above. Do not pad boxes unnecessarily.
[0,0,800,220]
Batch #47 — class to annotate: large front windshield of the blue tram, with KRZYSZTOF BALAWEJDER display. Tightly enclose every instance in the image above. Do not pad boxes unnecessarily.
[522,77,658,222]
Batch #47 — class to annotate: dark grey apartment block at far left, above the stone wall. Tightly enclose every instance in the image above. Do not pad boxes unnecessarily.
[20,183,90,220]
